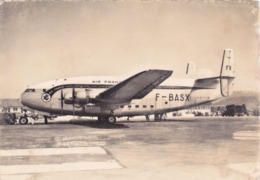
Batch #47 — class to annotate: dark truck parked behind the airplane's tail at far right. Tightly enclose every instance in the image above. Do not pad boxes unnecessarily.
[222,104,249,116]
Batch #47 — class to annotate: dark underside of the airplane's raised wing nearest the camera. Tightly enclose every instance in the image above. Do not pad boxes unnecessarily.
[95,70,172,103]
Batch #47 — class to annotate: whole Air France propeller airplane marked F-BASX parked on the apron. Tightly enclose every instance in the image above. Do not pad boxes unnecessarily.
[19,49,235,124]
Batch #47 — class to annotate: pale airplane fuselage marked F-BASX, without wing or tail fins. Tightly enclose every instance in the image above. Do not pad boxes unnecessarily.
[21,77,221,117]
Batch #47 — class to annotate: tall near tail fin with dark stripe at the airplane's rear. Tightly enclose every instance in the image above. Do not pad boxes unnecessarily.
[220,49,235,97]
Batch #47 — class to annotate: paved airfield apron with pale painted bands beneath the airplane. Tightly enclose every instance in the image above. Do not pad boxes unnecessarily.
[0,117,260,180]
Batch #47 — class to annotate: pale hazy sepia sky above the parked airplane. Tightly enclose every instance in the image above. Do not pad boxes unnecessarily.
[0,0,260,98]
